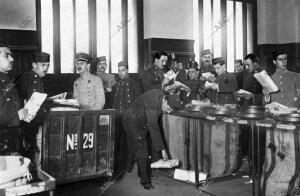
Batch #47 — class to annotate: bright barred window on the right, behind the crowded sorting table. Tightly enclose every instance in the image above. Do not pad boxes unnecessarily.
[193,0,255,72]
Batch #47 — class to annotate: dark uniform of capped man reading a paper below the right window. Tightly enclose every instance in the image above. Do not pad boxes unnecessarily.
[207,72,238,105]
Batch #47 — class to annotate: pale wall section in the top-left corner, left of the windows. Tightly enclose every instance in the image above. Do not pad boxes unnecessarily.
[0,0,36,30]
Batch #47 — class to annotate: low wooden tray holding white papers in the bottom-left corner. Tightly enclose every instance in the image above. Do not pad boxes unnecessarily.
[0,170,55,196]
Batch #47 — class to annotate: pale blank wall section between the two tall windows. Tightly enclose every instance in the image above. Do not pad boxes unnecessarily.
[144,0,193,39]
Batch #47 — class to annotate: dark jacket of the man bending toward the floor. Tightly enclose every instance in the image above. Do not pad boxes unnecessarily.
[123,89,165,151]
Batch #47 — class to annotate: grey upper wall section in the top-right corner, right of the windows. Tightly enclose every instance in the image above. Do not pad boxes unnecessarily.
[257,0,300,44]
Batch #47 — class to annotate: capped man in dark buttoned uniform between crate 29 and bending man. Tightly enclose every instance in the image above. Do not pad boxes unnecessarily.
[113,61,141,172]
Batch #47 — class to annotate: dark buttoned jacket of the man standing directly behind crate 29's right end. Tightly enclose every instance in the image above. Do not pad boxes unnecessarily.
[113,76,141,113]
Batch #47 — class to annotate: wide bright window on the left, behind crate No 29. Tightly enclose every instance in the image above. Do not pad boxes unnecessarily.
[39,0,138,74]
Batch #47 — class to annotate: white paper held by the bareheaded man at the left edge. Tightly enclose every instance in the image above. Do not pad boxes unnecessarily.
[24,92,47,122]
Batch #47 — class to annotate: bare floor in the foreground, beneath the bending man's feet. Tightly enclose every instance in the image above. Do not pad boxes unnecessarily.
[31,164,252,196]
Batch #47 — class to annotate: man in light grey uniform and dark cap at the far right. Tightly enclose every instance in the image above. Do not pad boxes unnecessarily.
[264,49,300,108]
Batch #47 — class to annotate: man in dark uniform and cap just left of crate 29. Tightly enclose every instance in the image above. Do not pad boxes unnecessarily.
[16,52,50,166]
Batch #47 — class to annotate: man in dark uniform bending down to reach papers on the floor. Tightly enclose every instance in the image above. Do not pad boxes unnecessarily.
[123,89,182,189]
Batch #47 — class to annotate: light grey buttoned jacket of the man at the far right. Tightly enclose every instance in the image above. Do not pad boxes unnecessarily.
[271,69,300,108]
